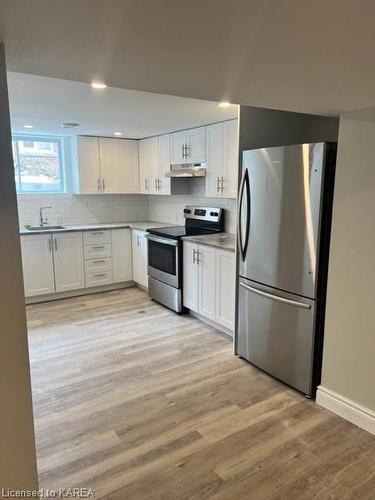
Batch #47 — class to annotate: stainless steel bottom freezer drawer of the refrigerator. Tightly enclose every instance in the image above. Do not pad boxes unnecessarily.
[236,278,316,395]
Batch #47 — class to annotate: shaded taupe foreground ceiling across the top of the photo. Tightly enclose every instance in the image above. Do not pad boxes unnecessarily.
[0,0,375,114]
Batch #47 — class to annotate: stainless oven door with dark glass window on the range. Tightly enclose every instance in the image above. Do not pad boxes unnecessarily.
[147,234,181,288]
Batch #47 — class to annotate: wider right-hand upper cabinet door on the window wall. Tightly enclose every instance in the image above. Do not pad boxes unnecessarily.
[99,137,139,194]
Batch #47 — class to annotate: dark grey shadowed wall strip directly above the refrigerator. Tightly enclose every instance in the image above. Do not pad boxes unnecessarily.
[240,106,339,152]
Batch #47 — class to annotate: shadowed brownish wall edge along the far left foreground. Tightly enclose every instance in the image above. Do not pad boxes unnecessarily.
[0,44,38,489]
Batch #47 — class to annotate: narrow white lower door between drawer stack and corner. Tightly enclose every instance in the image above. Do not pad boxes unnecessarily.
[112,228,133,283]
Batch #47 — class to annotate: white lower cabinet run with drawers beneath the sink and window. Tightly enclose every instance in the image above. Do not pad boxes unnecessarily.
[21,228,134,297]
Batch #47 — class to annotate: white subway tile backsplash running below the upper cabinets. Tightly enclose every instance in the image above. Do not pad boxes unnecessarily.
[18,179,236,233]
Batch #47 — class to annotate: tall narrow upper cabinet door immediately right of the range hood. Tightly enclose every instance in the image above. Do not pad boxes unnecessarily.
[206,123,224,198]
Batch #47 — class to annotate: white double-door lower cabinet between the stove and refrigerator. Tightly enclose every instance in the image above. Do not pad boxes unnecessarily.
[183,241,236,331]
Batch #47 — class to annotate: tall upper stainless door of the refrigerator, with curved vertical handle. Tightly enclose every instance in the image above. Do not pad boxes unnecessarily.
[238,143,325,298]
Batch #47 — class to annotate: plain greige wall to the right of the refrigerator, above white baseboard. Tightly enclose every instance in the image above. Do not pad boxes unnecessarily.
[322,111,375,411]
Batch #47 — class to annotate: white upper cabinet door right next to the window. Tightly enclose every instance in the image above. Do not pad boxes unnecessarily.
[72,137,101,194]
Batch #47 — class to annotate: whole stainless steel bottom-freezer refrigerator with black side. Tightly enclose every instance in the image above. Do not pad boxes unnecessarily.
[235,142,336,396]
